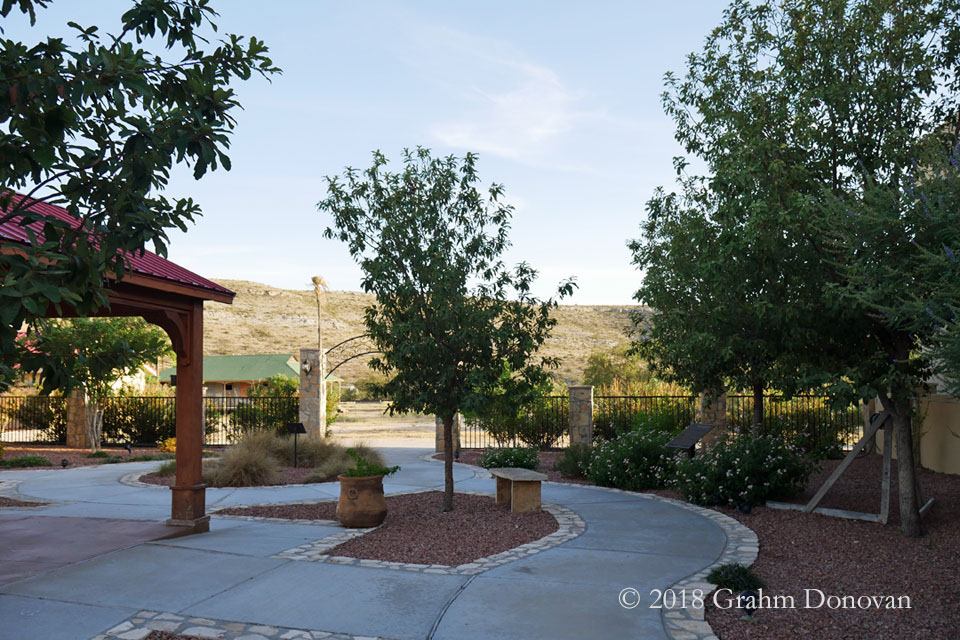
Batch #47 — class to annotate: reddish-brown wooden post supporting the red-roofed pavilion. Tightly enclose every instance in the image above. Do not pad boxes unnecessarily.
[167,300,210,533]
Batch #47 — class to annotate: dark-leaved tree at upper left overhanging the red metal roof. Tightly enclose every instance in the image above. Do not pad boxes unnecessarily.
[0,0,278,390]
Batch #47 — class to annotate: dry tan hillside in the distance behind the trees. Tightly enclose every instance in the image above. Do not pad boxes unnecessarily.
[204,280,640,383]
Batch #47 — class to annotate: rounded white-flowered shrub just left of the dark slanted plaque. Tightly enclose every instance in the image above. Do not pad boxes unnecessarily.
[589,431,681,491]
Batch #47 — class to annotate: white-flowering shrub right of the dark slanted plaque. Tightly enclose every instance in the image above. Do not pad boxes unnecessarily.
[675,433,813,505]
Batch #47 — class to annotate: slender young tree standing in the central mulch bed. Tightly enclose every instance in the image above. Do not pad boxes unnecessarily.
[318,148,574,511]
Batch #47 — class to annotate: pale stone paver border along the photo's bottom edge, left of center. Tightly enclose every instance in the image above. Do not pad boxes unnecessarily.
[92,611,398,640]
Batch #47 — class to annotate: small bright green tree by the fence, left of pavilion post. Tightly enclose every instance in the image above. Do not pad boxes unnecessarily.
[27,318,172,451]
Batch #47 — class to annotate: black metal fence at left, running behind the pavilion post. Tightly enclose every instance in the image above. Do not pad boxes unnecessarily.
[0,396,300,445]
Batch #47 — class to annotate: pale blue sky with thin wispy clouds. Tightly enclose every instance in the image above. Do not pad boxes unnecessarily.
[3,0,725,305]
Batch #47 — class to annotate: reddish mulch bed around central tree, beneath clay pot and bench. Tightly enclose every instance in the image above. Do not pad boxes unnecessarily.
[217,491,559,566]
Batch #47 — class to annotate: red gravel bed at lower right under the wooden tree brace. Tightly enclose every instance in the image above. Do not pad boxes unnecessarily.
[706,455,960,640]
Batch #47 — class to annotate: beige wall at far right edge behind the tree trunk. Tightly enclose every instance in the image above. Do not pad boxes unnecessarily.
[877,395,960,475]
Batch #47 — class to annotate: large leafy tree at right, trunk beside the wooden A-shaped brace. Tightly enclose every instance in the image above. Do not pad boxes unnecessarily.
[648,0,960,536]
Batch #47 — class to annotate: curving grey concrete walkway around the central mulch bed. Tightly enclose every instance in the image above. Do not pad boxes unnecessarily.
[0,447,755,640]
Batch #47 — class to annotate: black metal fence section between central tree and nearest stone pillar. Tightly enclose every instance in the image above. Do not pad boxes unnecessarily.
[460,396,570,449]
